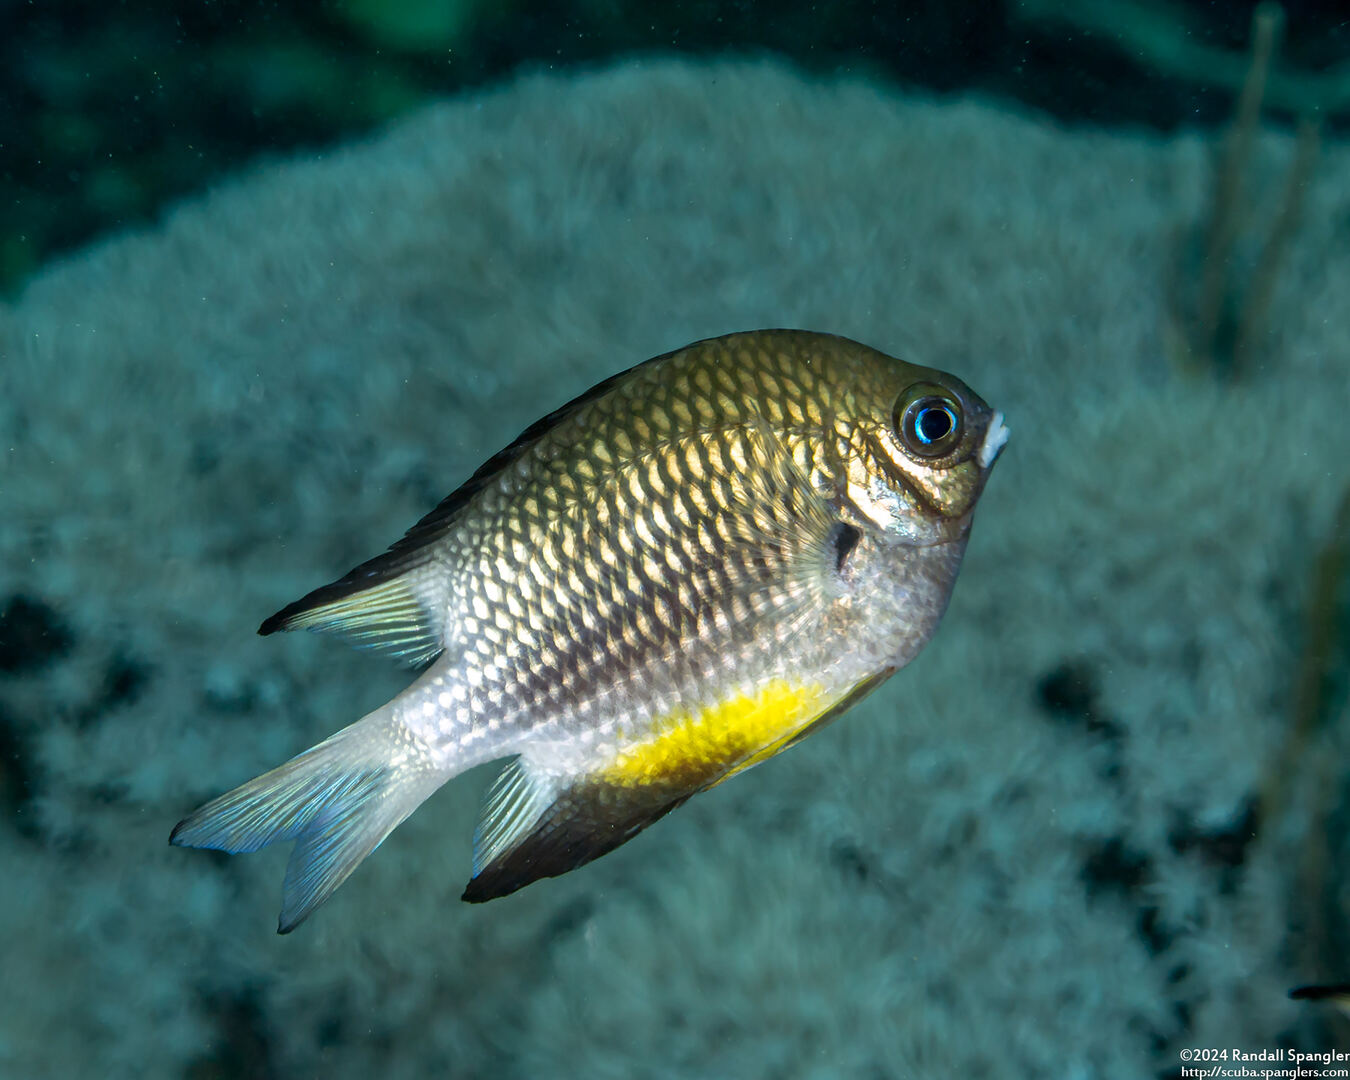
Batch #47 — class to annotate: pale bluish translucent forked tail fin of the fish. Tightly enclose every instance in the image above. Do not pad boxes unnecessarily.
[169,707,448,934]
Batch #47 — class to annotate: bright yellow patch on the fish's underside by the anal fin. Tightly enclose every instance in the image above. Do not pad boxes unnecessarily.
[597,679,833,788]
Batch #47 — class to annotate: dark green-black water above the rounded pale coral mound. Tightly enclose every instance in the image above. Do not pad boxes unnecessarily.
[0,0,1350,292]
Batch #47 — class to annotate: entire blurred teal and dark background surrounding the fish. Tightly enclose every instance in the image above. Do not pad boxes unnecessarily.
[0,3,1350,1077]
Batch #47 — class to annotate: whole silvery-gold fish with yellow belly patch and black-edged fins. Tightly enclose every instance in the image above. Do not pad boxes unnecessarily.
[171,331,1006,932]
